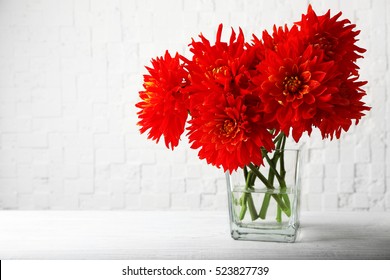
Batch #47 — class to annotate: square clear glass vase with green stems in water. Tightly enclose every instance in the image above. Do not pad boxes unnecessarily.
[226,148,302,242]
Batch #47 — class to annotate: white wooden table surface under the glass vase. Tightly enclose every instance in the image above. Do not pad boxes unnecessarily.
[0,211,390,260]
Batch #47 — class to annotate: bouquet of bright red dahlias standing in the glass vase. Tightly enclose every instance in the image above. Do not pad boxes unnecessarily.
[136,6,370,226]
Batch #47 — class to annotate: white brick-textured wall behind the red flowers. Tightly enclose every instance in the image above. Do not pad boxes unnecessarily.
[0,0,390,211]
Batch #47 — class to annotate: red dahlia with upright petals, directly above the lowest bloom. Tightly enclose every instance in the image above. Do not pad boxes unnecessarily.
[182,24,258,116]
